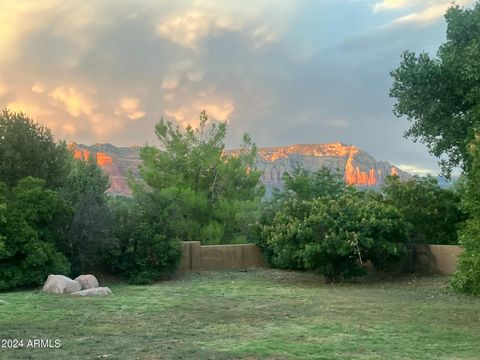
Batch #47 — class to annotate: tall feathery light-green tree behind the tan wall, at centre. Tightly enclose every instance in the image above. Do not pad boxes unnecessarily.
[134,112,263,244]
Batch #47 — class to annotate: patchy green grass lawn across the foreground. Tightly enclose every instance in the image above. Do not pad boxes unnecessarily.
[0,270,480,360]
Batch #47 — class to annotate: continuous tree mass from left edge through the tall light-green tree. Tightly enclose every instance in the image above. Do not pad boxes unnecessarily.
[0,110,264,290]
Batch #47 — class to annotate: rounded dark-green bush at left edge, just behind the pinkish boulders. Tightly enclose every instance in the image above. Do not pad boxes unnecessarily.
[0,177,72,290]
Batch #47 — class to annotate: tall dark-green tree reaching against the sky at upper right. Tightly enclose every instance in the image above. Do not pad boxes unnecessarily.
[390,2,480,175]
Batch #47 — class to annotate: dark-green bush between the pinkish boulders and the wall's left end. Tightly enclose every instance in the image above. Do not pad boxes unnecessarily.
[109,198,180,284]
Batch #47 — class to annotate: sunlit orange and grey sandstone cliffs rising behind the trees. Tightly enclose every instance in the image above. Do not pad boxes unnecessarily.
[71,143,410,196]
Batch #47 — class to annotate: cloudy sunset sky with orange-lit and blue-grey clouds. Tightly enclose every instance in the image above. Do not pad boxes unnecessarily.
[0,0,473,174]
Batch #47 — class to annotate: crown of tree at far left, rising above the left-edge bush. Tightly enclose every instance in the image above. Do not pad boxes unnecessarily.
[0,109,72,189]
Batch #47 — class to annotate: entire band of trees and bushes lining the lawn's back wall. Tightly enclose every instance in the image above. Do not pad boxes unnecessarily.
[0,110,465,290]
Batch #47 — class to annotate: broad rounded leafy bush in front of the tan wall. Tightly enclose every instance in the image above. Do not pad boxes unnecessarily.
[254,170,406,281]
